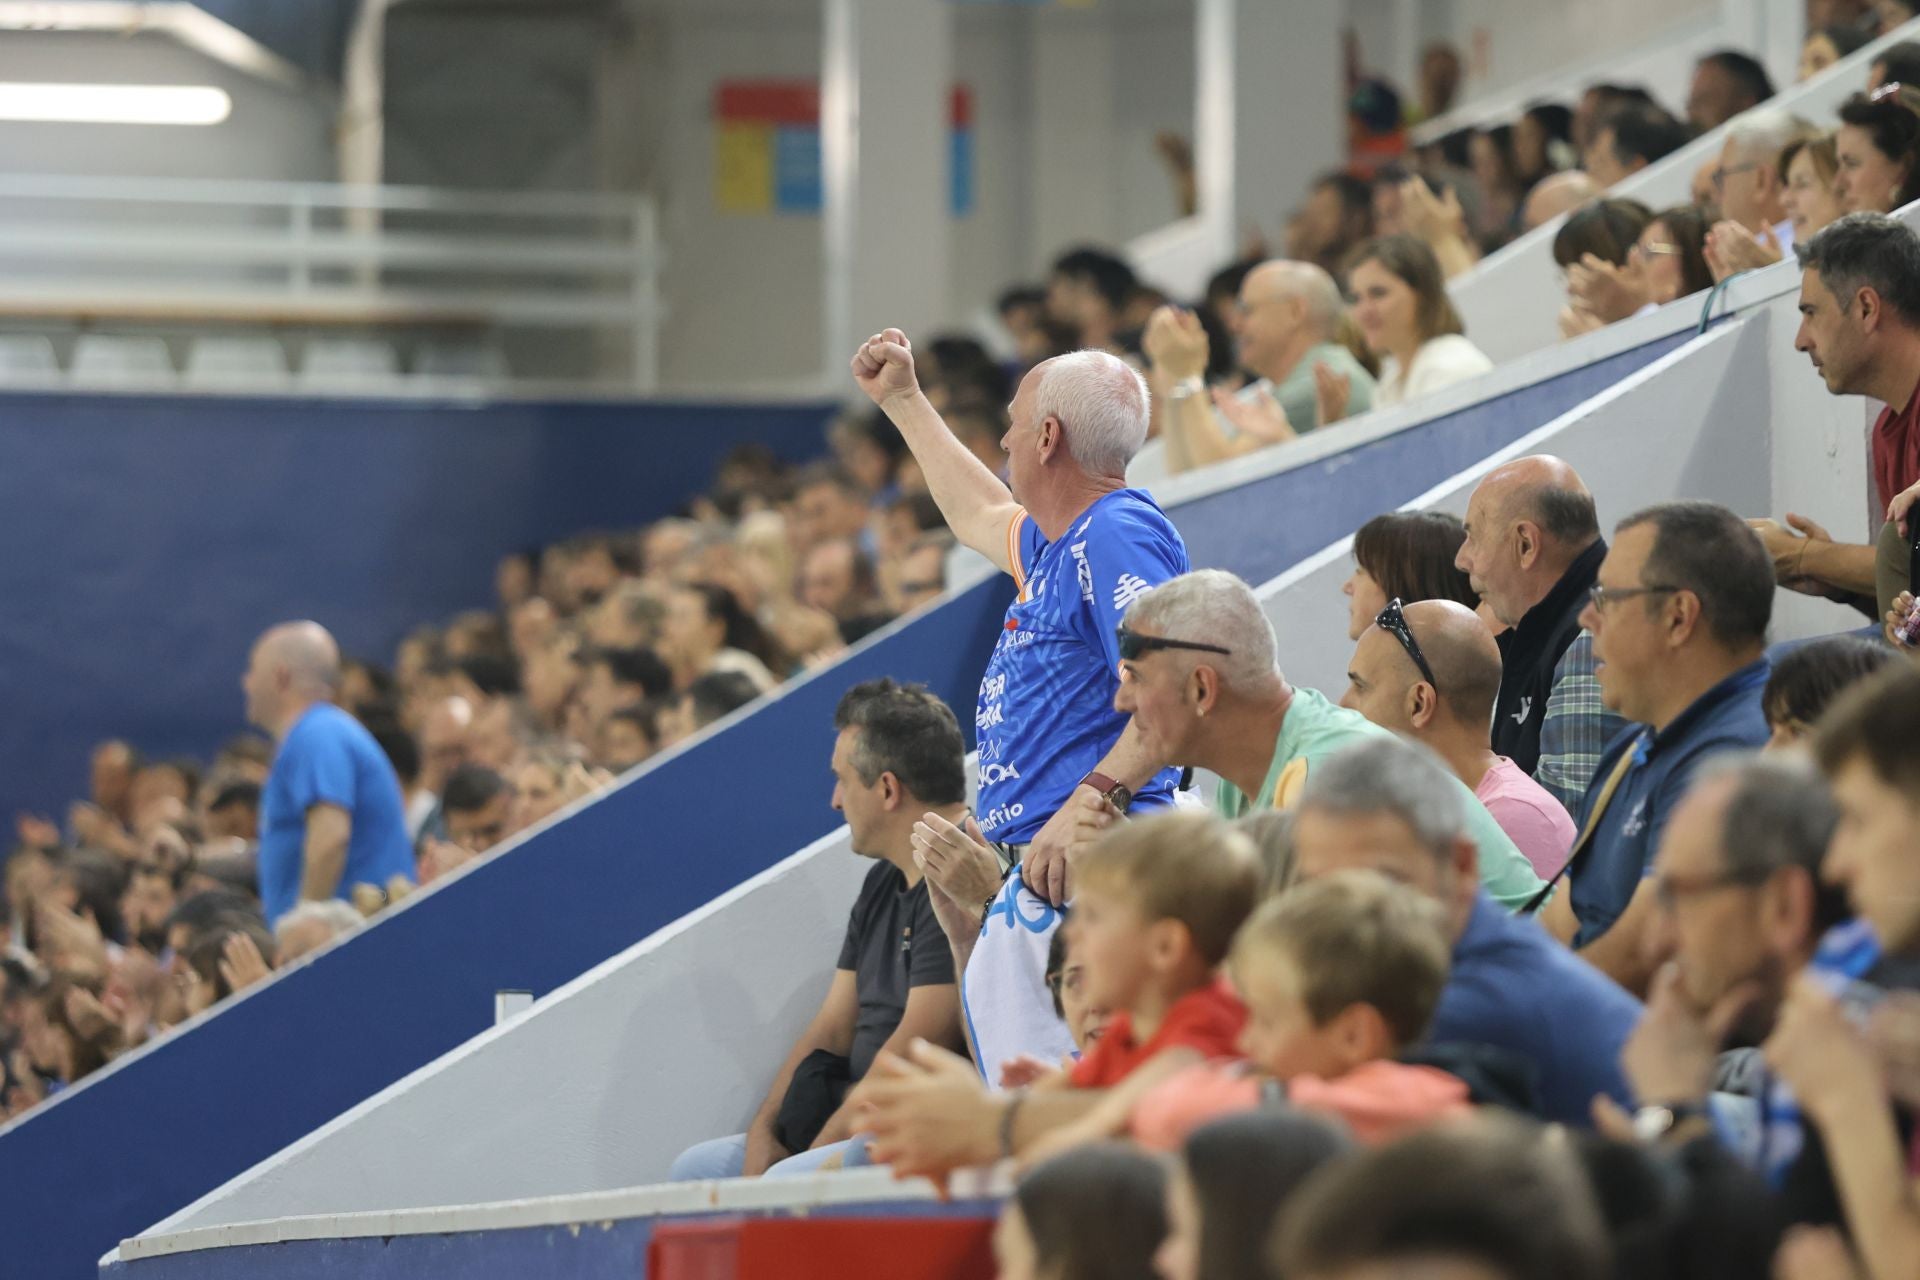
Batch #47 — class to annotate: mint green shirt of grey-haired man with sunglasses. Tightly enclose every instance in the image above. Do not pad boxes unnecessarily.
[1213,689,1542,912]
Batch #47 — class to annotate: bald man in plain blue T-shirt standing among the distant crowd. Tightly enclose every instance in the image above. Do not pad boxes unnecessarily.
[240,622,413,923]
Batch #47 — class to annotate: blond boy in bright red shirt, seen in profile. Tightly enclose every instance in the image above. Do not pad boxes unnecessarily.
[1020,814,1260,1161]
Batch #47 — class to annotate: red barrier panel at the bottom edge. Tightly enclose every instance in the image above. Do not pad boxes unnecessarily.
[647,1219,993,1280]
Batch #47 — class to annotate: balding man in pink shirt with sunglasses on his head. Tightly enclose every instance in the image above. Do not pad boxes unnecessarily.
[1340,601,1576,881]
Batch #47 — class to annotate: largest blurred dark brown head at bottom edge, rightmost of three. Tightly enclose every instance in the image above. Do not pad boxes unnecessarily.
[1267,1121,1613,1280]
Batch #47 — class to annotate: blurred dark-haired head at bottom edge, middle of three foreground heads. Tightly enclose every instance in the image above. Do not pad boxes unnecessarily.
[1154,1107,1352,1280]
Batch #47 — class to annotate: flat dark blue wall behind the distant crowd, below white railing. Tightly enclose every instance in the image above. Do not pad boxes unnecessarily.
[0,395,829,819]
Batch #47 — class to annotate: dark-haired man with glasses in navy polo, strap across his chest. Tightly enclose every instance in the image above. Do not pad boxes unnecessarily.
[1542,503,1774,994]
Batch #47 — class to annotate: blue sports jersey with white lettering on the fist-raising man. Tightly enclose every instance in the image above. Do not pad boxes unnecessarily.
[973,489,1190,844]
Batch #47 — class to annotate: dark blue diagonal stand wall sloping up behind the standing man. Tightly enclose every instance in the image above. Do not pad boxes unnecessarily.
[0,333,1672,1278]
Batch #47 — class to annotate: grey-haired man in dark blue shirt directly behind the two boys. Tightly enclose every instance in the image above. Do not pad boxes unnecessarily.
[1294,737,1640,1126]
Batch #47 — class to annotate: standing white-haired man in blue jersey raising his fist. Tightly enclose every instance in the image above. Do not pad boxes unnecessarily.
[852,328,1188,1080]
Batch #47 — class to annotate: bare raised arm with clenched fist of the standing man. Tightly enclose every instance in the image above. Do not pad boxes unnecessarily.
[852,328,1020,574]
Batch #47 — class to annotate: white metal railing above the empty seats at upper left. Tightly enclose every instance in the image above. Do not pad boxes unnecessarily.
[0,177,662,391]
